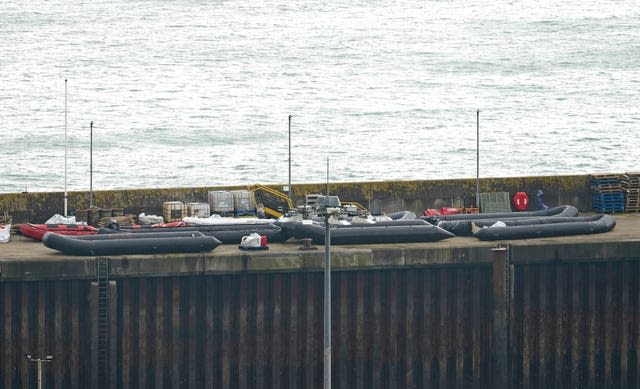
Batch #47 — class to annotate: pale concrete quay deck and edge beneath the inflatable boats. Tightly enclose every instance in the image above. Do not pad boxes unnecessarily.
[0,213,640,281]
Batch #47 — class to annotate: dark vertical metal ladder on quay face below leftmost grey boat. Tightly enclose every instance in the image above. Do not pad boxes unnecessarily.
[96,257,109,388]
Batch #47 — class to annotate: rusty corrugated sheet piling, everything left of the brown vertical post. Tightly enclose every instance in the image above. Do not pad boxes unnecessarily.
[0,266,491,388]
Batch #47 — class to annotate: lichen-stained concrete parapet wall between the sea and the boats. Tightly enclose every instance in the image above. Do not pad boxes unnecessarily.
[0,175,592,223]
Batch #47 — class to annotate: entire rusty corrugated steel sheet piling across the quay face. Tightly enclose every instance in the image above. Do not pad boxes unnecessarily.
[0,261,640,388]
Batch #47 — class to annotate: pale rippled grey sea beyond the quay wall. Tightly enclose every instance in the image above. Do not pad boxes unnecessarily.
[0,0,640,192]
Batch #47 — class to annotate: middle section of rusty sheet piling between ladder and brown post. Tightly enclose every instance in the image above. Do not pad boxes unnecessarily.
[118,269,490,388]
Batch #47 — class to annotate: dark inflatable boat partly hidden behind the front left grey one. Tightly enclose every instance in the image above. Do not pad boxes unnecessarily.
[99,223,290,244]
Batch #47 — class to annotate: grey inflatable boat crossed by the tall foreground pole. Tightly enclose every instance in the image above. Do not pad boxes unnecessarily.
[295,223,454,245]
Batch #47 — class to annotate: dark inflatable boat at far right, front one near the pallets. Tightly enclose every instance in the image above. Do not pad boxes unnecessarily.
[473,215,616,240]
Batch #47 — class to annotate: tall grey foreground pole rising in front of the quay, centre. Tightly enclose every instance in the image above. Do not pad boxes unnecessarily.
[323,158,331,389]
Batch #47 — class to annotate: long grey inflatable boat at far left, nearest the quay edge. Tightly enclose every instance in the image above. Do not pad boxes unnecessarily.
[42,232,220,256]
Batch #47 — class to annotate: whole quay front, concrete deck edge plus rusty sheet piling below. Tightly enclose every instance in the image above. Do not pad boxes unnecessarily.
[0,235,640,389]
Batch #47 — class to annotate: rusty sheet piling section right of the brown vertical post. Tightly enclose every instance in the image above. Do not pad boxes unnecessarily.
[510,261,640,388]
